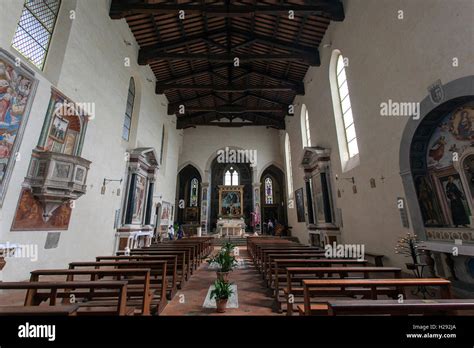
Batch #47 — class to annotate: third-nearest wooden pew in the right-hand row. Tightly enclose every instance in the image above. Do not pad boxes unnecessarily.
[284,266,402,315]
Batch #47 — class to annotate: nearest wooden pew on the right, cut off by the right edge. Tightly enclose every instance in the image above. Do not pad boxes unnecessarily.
[328,299,474,316]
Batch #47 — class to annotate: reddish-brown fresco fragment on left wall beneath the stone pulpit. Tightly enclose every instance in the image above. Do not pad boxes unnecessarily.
[11,189,72,231]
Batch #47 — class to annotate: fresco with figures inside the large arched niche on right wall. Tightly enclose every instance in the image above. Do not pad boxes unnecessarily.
[415,105,474,227]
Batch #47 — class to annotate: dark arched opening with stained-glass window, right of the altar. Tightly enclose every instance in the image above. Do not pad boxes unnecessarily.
[260,165,287,230]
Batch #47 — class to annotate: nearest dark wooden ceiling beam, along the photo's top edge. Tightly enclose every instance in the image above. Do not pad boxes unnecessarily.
[109,0,344,21]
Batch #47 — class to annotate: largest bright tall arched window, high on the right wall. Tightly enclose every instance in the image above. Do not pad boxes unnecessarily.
[329,50,359,169]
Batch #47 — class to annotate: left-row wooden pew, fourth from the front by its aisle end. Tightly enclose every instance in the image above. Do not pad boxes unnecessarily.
[95,255,183,300]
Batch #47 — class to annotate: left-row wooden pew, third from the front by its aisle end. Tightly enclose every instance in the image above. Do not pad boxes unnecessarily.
[69,261,168,314]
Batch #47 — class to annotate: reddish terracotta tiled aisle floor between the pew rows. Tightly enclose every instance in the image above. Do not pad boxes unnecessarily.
[162,247,281,316]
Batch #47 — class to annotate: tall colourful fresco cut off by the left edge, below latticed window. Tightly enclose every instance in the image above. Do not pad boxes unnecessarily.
[0,48,38,207]
